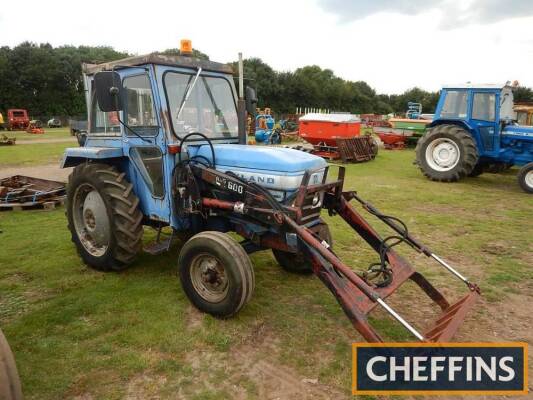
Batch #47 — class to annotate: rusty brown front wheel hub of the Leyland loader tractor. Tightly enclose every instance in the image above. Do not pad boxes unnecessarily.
[190,254,228,303]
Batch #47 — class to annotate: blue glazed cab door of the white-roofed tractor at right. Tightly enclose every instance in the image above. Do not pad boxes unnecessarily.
[471,91,500,155]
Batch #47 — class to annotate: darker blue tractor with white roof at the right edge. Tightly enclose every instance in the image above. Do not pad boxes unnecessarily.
[416,84,533,193]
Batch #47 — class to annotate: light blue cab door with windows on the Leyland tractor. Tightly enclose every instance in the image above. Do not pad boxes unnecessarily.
[121,68,171,223]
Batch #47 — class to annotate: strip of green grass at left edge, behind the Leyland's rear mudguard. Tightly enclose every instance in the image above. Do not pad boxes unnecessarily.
[0,142,74,168]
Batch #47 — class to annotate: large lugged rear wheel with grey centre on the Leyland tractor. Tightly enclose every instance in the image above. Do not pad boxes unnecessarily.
[67,163,143,271]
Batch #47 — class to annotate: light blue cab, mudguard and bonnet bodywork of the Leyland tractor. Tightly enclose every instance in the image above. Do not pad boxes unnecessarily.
[62,46,326,230]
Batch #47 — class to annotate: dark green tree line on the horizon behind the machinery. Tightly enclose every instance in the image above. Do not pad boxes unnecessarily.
[0,42,533,116]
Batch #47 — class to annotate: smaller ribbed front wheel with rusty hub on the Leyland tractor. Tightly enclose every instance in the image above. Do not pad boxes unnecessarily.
[178,231,255,318]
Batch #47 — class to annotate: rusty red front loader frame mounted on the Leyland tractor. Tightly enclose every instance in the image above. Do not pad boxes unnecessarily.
[175,163,480,342]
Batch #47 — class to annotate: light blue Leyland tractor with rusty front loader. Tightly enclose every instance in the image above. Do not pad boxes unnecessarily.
[62,45,479,341]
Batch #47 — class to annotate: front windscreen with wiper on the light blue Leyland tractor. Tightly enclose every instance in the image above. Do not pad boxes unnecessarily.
[164,72,238,139]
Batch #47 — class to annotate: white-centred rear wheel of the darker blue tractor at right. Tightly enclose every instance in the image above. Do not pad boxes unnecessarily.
[415,125,479,182]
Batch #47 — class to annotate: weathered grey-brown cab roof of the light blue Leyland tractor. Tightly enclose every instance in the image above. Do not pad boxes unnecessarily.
[82,53,233,75]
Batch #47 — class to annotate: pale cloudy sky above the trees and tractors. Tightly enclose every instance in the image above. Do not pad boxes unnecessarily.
[0,0,533,94]
